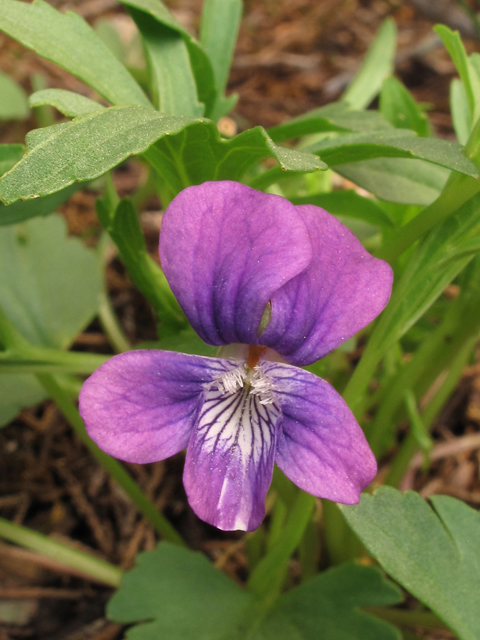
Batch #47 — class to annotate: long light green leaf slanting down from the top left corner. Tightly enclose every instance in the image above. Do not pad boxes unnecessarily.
[0,0,151,107]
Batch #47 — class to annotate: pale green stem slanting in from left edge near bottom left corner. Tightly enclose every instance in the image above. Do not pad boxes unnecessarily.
[0,518,122,587]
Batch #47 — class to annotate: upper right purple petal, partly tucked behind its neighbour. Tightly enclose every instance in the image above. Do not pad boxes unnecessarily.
[261,205,393,365]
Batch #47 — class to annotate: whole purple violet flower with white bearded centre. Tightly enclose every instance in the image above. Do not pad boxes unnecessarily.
[80,182,392,531]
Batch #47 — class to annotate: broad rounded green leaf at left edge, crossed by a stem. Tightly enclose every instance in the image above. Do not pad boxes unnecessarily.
[0,216,103,425]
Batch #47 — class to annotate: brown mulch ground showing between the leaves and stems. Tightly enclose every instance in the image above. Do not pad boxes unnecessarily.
[0,0,480,640]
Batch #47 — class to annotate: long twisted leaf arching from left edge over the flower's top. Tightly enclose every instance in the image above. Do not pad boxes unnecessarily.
[0,107,325,204]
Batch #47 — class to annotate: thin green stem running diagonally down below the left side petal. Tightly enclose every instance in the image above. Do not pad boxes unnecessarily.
[37,374,186,546]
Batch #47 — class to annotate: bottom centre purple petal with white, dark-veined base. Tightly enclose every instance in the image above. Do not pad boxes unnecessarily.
[183,376,281,531]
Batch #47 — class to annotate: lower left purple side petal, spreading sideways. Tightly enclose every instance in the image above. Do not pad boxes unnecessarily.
[79,351,236,464]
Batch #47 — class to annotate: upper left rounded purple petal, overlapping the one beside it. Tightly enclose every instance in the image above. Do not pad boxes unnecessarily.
[160,181,312,345]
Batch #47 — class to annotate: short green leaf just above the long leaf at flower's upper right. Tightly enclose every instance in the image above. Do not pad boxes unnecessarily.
[268,102,392,142]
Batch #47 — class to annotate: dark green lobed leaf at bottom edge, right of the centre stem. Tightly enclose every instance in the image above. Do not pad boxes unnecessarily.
[253,564,402,640]
